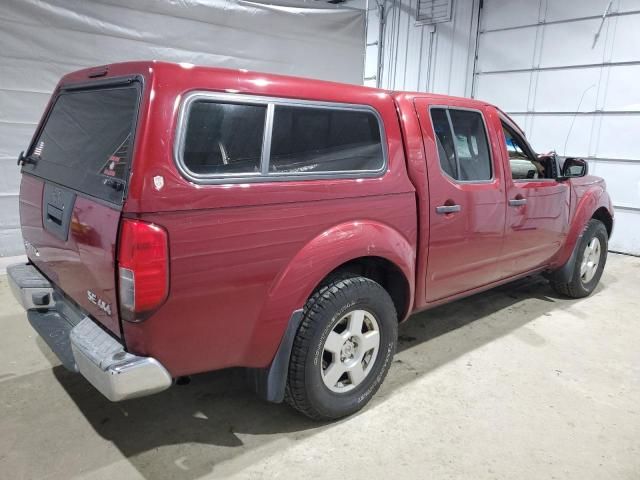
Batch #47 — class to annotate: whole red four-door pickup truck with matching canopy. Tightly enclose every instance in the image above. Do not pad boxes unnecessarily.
[8,62,613,419]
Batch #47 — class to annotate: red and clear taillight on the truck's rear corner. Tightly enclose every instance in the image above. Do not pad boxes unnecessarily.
[118,219,169,321]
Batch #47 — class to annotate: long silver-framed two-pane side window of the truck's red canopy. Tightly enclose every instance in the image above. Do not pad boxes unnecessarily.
[175,93,386,183]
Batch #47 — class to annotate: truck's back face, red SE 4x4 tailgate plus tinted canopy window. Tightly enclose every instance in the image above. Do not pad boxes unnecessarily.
[20,81,141,336]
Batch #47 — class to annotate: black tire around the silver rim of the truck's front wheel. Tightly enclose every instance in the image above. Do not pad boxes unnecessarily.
[550,219,609,298]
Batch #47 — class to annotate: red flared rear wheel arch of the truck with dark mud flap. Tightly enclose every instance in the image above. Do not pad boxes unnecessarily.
[247,221,415,402]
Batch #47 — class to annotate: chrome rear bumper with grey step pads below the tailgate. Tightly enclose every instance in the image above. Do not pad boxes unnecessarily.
[7,264,172,402]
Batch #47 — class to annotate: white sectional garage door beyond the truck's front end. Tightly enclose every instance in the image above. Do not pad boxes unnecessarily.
[474,0,640,255]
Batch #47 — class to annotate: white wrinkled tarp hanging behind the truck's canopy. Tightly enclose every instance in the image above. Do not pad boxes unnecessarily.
[0,0,365,256]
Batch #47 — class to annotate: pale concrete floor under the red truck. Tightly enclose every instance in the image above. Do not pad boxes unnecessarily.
[0,255,640,480]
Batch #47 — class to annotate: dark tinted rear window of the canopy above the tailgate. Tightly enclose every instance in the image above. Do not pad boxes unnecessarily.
[23,82,141,205]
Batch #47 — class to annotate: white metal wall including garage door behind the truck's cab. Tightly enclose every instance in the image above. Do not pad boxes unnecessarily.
[365,0,640,254]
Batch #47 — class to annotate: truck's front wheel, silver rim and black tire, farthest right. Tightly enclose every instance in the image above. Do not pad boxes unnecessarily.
[551,219,608,298]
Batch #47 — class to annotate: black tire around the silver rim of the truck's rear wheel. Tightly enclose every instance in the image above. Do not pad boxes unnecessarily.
[285,277,398,420]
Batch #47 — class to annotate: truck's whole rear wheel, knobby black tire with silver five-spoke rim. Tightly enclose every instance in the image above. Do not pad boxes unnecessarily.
[285,277,398,420]
